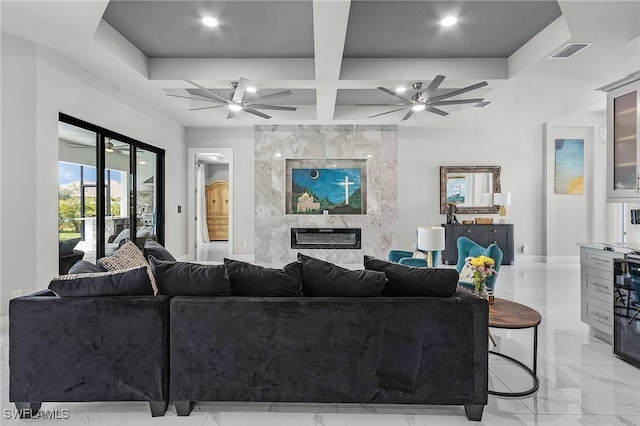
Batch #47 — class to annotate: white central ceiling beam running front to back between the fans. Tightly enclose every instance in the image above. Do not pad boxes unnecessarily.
[313,0,351,122]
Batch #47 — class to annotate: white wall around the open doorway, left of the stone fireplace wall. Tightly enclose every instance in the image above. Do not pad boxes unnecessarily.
[186,127,255,259]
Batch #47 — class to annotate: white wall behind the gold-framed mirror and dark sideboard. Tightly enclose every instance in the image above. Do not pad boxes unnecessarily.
[398,125,545,256]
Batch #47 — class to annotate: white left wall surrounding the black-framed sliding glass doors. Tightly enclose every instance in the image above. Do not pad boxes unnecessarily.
[0,35,186,315]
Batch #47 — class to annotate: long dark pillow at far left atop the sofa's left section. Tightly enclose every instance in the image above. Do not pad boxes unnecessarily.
[49,266,153,297]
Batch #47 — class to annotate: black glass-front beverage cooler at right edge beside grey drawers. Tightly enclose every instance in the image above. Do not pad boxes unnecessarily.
[613,254,640,368]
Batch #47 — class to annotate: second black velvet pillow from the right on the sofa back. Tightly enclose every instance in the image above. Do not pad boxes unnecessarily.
[298,253,386,297]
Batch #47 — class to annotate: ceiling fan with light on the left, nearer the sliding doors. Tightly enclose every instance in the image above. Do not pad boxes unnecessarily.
[166,77,297,119]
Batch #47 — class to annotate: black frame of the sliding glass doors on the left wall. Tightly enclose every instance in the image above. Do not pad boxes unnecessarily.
[58,112,165,259]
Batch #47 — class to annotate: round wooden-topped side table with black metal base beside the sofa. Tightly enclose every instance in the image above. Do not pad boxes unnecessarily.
[489,298,542,397]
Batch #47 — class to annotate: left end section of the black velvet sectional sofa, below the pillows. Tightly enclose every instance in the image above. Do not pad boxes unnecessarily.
[9,293,169,414]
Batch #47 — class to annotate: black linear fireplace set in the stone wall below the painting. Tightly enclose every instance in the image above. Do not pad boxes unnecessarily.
[291,228,362,249]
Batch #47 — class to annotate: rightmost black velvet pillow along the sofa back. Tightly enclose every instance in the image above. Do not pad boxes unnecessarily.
[364,256,458,297]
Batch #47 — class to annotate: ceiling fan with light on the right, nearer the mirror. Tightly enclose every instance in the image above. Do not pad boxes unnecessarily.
[356,75,487,121]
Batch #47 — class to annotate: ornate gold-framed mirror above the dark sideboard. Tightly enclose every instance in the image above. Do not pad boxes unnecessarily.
[440,166,501,214]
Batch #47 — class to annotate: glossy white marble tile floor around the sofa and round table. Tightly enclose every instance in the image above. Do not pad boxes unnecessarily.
[0,260,640,426]
